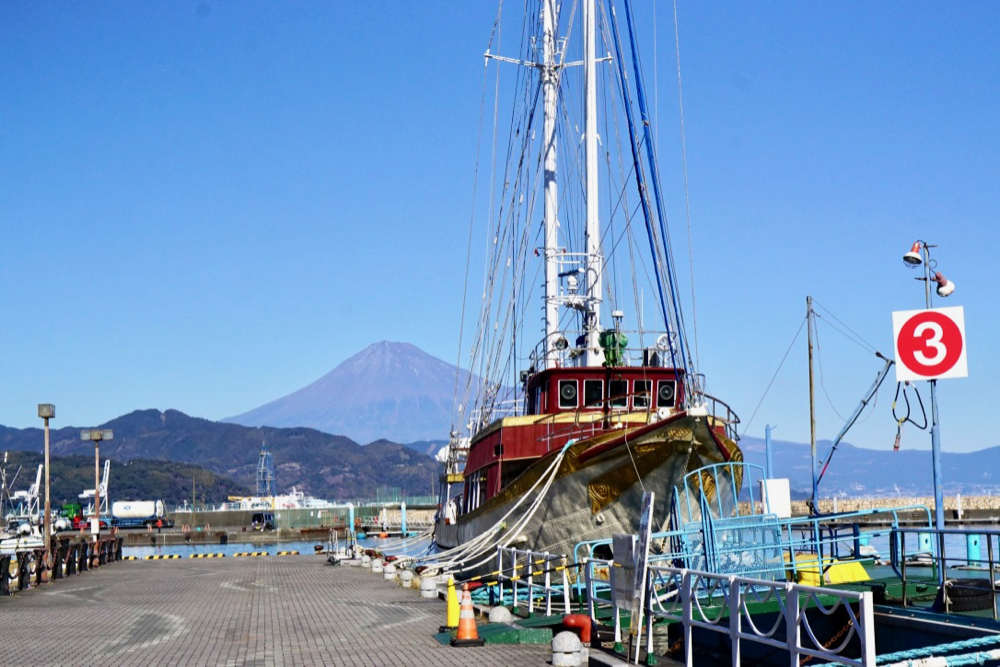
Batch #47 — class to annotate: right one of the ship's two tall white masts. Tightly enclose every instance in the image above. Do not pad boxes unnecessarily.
[583,0,604,366]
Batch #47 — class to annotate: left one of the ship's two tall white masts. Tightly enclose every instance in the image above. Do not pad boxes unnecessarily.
[542,0,559,366]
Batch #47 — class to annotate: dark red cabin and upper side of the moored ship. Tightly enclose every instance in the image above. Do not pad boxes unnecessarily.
[461,366,684,514]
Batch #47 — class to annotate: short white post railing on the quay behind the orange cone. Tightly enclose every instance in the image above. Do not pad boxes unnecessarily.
[497,547,572,616]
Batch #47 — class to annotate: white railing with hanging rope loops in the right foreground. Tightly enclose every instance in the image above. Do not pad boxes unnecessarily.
[646,566,875,667]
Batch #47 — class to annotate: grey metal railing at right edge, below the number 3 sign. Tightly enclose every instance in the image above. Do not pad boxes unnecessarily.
[889,527,1000,620]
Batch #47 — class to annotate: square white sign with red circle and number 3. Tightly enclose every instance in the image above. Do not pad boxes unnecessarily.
[892,306,969,382]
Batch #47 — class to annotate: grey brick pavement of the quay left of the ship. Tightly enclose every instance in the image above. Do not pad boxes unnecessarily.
[0,555,551,667]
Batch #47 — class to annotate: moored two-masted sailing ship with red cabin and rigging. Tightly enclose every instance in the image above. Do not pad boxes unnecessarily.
[434,0,742,567]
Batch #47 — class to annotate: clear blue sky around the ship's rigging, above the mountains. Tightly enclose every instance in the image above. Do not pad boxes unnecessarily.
[0,0,1000,452]
